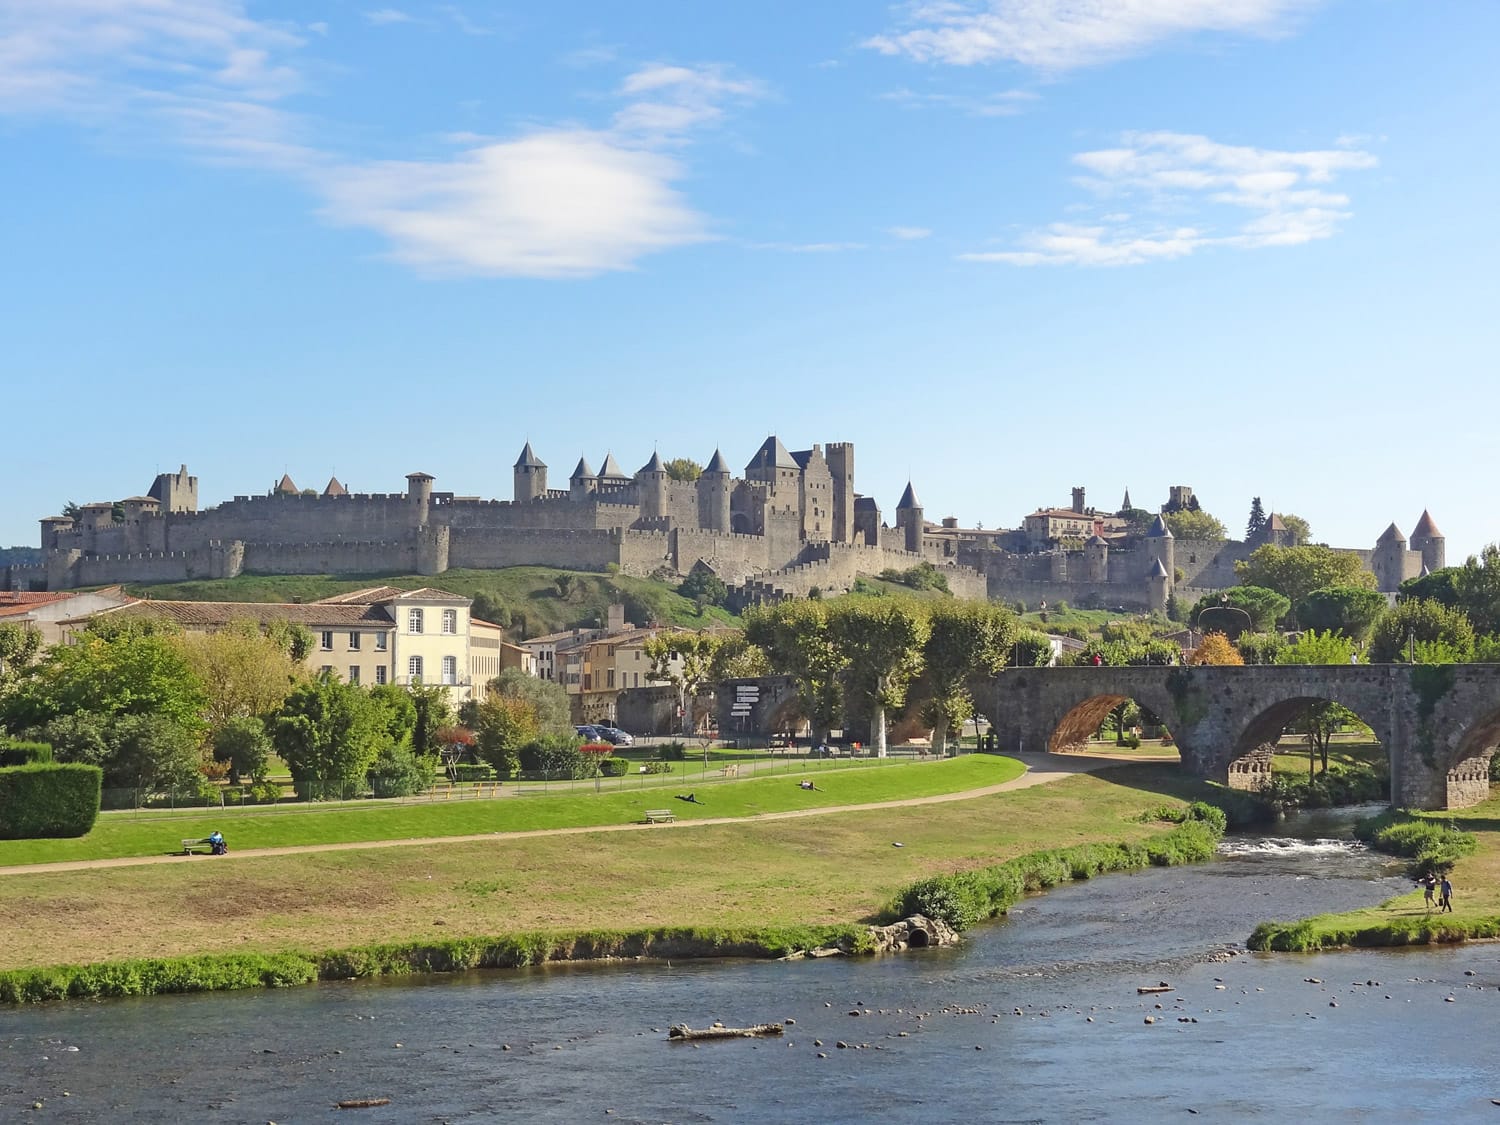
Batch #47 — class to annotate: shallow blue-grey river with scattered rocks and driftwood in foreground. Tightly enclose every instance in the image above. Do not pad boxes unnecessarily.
[0,816,1500,1125]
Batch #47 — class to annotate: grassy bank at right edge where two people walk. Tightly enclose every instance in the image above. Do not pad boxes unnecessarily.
[1250,795,1500,953]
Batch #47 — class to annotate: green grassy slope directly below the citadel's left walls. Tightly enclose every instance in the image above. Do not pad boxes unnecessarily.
[126,567,738,638]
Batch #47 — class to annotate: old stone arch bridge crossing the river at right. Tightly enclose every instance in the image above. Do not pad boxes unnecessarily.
[990,665,1500,809]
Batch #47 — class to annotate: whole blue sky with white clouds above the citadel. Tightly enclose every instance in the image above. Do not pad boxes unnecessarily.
[0,0,1500,561]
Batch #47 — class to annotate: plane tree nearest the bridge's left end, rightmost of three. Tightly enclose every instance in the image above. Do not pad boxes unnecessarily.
[923,602,1016,756]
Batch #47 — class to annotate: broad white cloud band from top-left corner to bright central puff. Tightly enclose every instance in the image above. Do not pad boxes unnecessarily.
[0,0,761,279]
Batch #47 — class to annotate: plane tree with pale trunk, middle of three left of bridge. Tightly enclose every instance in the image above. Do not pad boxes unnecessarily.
[828,597,930,758]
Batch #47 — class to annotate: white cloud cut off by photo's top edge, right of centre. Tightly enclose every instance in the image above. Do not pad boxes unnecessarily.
[864,0,1320,71]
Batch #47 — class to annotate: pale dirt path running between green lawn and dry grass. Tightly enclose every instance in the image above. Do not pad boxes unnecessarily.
[0,753,1131,876]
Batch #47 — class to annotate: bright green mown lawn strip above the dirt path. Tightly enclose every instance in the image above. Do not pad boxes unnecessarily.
[0,755,1025,867]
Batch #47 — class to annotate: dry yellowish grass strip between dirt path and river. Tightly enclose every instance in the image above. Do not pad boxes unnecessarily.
[0,764,1230,975]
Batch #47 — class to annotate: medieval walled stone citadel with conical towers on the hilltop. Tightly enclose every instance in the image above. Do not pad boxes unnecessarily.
[0,437,1445,609]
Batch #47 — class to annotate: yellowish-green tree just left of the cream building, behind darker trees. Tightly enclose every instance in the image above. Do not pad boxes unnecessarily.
[171,623,306,732]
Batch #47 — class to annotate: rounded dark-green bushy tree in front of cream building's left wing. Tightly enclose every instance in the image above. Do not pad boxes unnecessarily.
[272,675,395,797]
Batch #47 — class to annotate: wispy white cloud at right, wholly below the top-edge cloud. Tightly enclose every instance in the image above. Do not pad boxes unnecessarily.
[960,132,1377,266]
